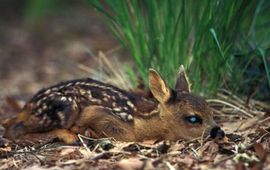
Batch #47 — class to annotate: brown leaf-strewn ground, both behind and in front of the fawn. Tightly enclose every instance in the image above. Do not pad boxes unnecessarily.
[0,1,270,170]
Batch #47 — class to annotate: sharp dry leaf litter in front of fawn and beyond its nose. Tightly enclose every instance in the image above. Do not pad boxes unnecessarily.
[0,92,270,170]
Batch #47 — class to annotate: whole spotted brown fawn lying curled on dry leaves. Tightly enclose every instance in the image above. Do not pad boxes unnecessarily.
[4,65,225,144]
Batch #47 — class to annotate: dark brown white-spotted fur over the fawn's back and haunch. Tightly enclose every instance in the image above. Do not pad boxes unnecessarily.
[25,78,156,127]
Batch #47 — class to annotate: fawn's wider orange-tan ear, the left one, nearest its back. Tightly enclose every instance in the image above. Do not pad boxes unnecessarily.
[149,69,171,103]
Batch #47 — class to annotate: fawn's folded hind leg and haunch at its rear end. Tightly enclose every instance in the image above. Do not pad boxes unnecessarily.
[4,98,79,139]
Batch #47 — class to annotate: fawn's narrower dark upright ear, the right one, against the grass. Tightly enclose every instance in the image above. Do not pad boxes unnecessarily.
[175,65,191,93]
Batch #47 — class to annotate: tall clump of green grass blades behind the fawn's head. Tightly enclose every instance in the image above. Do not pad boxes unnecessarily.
[87,0,270,98]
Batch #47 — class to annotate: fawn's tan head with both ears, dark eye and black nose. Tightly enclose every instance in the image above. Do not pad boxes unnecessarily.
[149,65,225,140]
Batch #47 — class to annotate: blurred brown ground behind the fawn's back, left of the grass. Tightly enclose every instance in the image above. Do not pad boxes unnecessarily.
[0,7,118,96]
